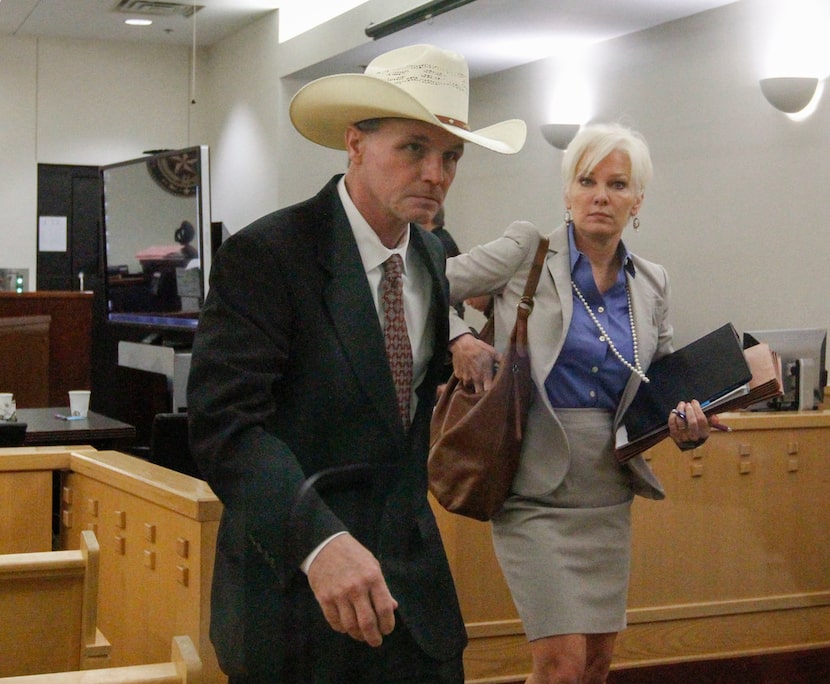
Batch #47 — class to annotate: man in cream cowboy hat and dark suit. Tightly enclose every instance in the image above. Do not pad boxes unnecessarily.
[188,45,525,684]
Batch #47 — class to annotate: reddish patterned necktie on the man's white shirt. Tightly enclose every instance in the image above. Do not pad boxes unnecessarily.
[381,254,420,430]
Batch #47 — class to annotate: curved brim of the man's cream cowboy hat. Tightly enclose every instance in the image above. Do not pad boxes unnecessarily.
[288,74,527,154]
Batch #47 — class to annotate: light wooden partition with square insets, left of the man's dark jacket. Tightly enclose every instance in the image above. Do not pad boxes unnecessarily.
[61,451,226,683]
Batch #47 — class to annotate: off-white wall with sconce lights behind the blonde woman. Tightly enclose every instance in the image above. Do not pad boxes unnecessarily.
[447,1,830,343]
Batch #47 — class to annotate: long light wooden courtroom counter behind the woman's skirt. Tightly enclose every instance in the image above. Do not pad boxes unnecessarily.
[433,410,830,684]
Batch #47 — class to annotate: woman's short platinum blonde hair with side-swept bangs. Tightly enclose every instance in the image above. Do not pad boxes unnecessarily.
[562,123,654,195]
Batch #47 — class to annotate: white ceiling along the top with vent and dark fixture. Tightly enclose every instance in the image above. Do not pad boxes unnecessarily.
[0,0,736,76]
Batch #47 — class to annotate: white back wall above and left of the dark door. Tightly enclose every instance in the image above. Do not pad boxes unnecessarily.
[0,36,207,280]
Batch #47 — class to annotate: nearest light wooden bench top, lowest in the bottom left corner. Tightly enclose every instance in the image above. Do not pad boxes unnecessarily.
[0,636,202,684]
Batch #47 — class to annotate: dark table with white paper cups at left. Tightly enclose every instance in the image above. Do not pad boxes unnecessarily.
[17,406,135,449]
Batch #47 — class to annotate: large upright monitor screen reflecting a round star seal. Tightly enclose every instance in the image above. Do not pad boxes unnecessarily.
[101,145,211,338]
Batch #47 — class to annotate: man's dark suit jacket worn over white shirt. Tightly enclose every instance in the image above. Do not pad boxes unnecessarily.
[188,177,466,673]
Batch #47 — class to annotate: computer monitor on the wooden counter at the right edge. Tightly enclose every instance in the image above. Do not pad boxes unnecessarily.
[743,328,827,411]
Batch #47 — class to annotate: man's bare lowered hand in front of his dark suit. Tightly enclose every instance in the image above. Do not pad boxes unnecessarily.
[308,534,398,646]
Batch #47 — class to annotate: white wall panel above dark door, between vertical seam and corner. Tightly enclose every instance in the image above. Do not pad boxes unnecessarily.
[35,39,200,165]
